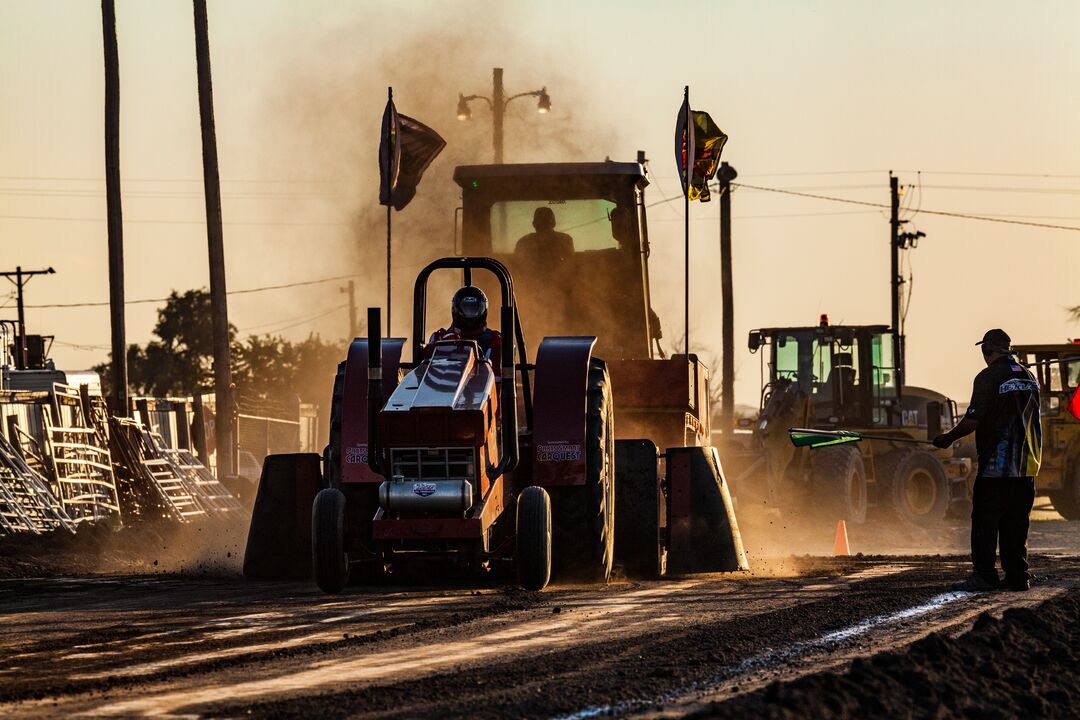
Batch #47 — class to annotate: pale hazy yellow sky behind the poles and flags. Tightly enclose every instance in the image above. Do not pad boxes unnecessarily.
[0,0,1080,404]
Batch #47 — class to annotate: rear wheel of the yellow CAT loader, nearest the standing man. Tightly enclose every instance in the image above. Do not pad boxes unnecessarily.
[877,450,949,528]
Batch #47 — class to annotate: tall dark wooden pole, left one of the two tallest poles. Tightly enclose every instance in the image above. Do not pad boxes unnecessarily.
[102,0,127,417]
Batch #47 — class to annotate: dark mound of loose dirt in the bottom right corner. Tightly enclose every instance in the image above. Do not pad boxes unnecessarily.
[692,590,1080,718]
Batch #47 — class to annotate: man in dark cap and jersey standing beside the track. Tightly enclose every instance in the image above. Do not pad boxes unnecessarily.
[933,328,1042,590]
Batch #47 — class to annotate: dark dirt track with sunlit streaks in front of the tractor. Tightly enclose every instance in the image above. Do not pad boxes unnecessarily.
[0,535,1080,718]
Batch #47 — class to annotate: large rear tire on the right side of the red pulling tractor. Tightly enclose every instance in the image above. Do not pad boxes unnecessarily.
[553,358,615,582]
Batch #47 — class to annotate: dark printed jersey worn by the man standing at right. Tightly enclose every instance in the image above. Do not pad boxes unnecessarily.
[964,355,1042,477]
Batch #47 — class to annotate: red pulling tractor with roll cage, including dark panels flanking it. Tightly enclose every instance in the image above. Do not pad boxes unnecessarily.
[244,257,745,592]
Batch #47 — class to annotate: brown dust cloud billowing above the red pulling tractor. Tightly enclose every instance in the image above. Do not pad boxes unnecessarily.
[247,13,616,345]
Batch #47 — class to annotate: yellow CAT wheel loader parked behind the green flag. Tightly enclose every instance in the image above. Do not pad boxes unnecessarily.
[726,315,972,526]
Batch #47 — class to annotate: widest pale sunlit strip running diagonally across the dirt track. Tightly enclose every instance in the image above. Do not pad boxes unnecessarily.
[48,563,910,716]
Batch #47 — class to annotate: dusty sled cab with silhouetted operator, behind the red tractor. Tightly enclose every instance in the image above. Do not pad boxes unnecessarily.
[454,162,660,359]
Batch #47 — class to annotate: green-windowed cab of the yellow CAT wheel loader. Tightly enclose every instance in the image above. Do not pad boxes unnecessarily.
[750,322,900,427]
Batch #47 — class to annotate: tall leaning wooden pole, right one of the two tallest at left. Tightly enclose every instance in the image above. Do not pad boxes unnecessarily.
[193,0,238,477]
